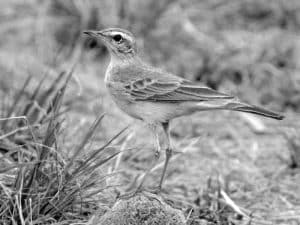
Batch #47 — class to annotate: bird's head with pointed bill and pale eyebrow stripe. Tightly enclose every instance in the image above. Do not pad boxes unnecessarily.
[83,28,137,59]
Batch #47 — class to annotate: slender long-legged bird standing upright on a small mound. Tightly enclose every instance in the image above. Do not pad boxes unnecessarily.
[84,28,284,190]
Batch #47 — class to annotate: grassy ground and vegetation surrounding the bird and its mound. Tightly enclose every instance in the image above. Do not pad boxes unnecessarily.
[0,0,300,225]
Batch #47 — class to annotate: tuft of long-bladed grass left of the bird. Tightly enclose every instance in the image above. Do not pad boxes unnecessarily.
[0,71,125,225]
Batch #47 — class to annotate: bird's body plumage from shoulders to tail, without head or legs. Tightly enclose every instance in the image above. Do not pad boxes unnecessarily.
[106,63,282,123]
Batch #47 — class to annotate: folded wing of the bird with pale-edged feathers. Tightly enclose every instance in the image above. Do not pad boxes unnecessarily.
[124,71,234,102]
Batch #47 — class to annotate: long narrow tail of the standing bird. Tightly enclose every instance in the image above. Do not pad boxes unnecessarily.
[224,101,284,120]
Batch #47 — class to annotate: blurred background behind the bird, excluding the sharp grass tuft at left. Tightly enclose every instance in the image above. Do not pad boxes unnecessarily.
[0,0,300,224]
